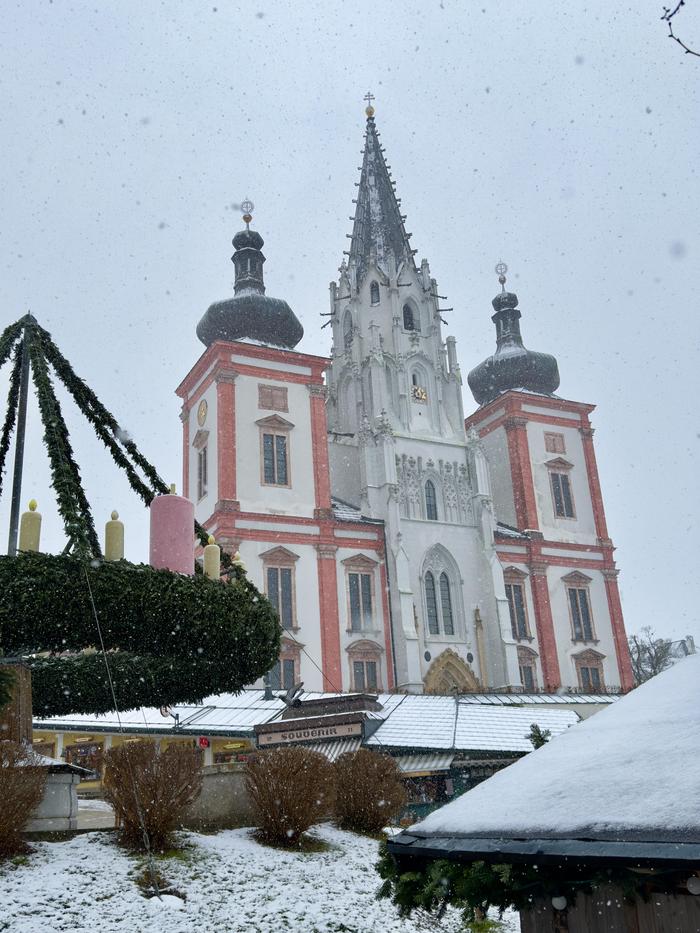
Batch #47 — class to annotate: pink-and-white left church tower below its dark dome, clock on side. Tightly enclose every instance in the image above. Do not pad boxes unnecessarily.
[177,341,394,691]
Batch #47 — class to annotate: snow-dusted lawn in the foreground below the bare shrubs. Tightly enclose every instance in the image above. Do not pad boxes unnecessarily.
[0,825,520,933]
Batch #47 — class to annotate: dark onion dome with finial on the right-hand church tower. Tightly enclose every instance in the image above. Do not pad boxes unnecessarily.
[467,262,559,405]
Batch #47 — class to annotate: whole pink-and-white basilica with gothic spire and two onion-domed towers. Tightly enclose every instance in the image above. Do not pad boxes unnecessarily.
[177,106,633,694]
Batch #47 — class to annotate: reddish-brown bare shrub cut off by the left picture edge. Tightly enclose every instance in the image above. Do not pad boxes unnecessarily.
[0,742,47,858]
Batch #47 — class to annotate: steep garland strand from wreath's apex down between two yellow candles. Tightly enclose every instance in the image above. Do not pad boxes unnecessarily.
[25,325,102,557]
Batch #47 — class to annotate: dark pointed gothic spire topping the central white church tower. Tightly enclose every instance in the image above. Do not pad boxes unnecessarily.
[349,94,415,285]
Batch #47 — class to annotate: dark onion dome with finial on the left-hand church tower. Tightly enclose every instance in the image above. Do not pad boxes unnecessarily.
[197,201,304,349]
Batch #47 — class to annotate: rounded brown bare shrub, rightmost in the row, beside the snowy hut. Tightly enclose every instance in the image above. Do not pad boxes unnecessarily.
[335,748,407,833]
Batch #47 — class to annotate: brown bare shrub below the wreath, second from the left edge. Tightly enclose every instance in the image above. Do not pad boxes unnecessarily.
[104,741,202,850]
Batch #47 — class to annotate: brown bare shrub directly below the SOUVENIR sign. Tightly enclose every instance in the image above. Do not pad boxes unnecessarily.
[246,746,335,846]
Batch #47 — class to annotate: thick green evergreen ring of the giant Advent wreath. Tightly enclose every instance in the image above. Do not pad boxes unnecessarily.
[0,552,280,716]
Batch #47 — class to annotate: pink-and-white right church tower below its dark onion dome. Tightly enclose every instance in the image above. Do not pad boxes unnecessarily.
[466,390,634,690]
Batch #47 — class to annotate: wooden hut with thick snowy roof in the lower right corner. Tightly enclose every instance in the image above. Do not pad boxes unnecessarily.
[389,655,700,933]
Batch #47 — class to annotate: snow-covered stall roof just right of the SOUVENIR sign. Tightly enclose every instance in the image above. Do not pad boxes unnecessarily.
[366,695,579,753]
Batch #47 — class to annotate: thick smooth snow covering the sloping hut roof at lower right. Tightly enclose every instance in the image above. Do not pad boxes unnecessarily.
[404,655,700,848]
